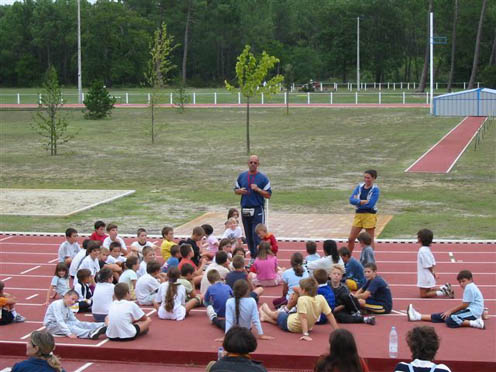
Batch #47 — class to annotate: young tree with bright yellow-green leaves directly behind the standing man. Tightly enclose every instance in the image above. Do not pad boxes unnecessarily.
[225,45,284,154]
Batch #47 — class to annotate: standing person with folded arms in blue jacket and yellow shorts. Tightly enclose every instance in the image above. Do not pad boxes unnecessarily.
[348,169,380,253]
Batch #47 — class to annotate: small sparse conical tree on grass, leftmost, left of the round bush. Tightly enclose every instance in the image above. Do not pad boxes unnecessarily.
[31,66,73,156]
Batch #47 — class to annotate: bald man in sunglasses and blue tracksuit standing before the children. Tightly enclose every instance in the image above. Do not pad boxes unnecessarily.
[234,155,272,261]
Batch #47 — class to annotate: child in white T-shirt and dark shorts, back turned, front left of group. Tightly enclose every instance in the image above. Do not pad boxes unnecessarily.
[106,283,152,341]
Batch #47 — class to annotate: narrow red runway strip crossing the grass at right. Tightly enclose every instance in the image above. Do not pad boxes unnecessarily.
[405,116,487,173]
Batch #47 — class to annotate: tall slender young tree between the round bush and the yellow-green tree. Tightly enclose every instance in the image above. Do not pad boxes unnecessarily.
[145,23,179,144]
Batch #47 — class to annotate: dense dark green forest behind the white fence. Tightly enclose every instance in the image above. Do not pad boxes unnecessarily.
[0,0,496,87]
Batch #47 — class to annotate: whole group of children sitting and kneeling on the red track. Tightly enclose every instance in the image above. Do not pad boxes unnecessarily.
[0,215,484,341]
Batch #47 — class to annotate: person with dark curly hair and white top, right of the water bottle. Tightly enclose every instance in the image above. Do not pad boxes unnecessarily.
[394,326,451,372]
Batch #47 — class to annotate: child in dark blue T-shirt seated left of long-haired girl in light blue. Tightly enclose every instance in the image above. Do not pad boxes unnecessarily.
[203,269,233,330]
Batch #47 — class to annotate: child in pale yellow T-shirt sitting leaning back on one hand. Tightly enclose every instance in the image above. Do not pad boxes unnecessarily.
[260,278,338,341]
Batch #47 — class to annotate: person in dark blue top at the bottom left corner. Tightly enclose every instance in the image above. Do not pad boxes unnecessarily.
[12,331,65,372]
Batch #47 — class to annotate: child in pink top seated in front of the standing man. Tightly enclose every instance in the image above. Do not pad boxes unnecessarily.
[250,241,281,287]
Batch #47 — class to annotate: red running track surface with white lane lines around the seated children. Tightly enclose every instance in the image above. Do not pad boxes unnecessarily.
[0,234,496,372]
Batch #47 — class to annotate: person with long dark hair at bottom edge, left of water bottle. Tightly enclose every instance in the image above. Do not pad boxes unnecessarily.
[314,328,363,372]
